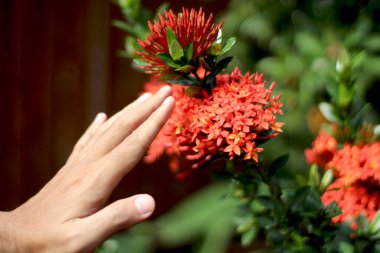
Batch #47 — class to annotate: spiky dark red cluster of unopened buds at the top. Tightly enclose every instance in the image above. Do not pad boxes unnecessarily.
[136,8,223,74]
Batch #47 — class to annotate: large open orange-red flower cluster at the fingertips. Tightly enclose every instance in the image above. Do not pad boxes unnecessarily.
[145,68,284,177]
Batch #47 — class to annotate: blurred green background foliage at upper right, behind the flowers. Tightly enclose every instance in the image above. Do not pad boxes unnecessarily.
[221,0,380,173]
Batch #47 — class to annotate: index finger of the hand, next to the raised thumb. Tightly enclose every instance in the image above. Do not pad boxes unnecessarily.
[101,97,175,185]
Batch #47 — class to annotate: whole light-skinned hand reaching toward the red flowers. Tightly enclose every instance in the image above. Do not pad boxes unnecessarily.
[0,86,174,253]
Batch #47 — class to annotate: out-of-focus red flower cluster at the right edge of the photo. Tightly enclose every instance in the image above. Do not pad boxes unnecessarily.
[305,132,380,222]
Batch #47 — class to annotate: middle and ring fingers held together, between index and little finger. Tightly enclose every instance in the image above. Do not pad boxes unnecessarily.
[82,86,172,159]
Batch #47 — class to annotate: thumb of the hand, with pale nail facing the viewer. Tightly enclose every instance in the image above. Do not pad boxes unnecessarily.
[76,194,155,251]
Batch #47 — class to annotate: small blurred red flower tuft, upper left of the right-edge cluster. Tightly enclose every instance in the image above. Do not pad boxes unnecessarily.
[305,131,338,168]
